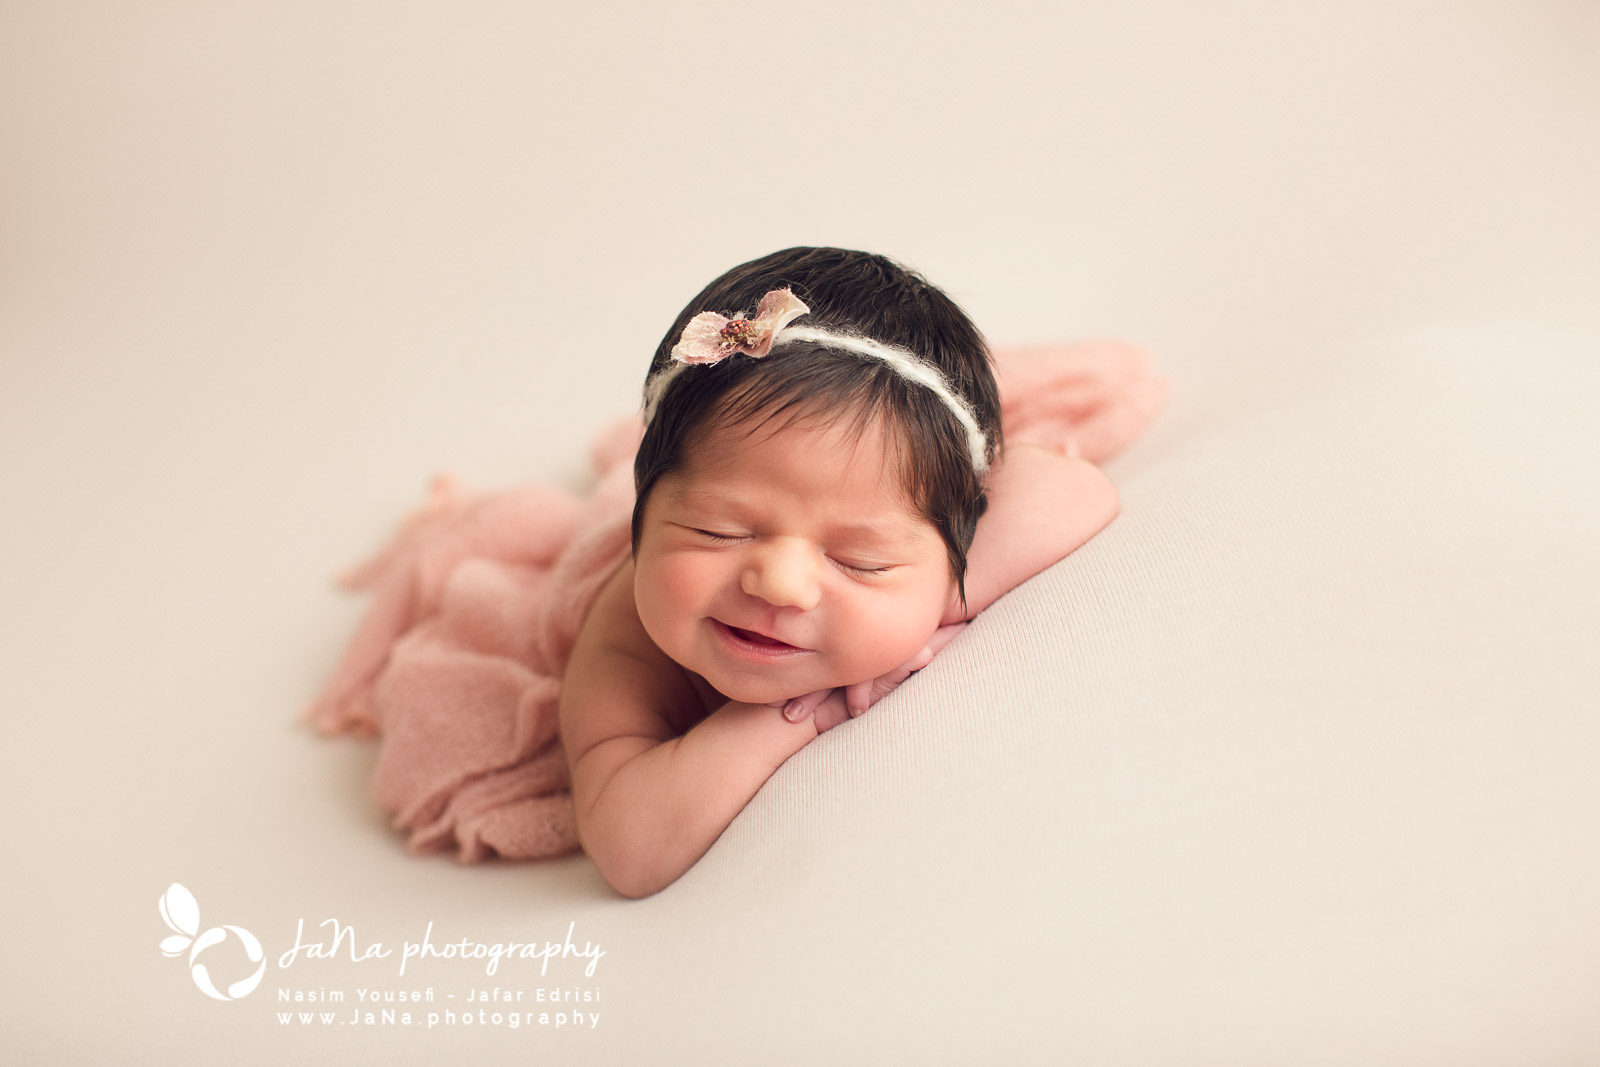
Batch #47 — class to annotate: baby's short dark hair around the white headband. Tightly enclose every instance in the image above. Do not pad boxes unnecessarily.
[634,248,1000,601]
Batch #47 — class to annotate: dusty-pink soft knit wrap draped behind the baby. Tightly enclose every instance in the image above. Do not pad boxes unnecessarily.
[307,342,1166,862]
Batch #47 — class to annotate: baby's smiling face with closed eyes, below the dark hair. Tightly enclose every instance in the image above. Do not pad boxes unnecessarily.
[634,419,957,704]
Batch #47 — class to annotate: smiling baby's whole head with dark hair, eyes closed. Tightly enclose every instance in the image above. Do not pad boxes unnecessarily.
[634,248,1000,701]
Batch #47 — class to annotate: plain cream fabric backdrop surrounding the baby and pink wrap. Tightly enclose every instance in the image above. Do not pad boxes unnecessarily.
[0,0,1600,1064]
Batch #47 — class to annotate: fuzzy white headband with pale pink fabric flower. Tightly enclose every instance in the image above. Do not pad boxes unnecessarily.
[645,290,989,474]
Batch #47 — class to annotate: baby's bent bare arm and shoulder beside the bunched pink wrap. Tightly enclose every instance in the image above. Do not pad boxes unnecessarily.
[562,563,818,897]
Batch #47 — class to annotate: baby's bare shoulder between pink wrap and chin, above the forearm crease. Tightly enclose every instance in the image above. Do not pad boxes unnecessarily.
[562,561,706,763]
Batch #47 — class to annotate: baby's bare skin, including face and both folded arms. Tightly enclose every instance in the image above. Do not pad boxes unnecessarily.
[560,427,1117,897]
